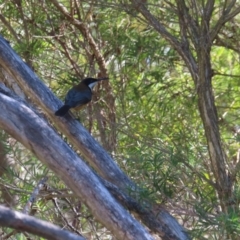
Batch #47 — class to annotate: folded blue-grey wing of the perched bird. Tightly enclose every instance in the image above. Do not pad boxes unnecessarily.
[65,88,92,108]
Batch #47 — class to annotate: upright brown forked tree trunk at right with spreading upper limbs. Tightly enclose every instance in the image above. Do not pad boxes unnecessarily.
[131,0,236,213]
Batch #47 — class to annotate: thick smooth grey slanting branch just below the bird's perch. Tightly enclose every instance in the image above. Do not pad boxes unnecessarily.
[0,85,152,240]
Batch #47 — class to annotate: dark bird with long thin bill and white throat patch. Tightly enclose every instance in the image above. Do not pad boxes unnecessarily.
[55,77,108,116]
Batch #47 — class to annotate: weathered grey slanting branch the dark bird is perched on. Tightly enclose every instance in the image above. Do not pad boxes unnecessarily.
[0,37,188,239]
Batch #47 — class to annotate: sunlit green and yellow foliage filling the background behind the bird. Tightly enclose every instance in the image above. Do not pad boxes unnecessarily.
[0,0,240,239]
